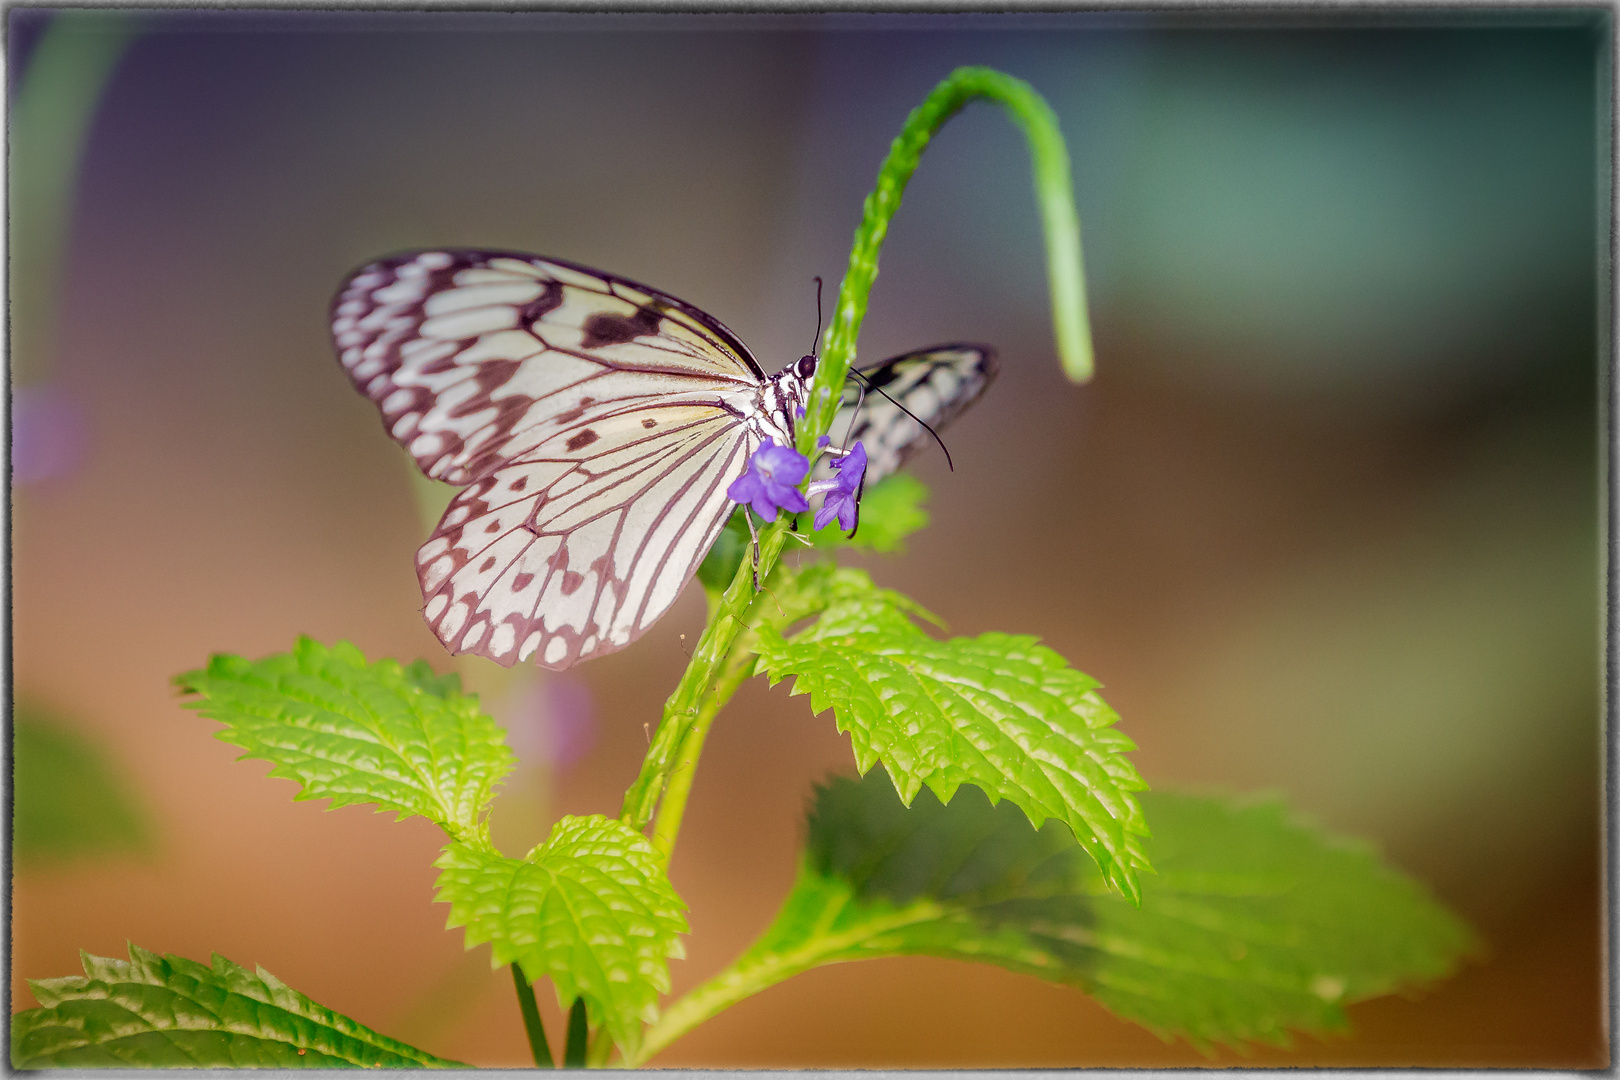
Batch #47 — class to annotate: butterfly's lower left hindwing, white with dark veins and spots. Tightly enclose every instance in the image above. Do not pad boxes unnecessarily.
[418,405,753,667]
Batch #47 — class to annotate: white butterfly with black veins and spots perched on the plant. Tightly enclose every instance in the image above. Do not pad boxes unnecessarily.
[332,249,996,669]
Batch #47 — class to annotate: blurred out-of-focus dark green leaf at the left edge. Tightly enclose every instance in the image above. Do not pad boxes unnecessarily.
[11,703,151,866]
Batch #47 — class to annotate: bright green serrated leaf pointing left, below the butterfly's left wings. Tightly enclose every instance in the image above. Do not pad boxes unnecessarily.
[175,638,515,840]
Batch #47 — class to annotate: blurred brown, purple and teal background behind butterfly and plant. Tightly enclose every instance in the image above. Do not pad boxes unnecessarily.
[8,8,1610,1067]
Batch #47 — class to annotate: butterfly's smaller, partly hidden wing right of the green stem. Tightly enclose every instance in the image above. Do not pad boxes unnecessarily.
[816,343,998,487]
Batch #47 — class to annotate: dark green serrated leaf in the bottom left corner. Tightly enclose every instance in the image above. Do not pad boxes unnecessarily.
[11,946,465,1069]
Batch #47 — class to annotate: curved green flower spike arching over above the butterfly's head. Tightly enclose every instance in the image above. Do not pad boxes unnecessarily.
[799,68,1092,453]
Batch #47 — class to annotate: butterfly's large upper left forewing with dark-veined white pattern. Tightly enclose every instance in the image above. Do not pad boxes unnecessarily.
[332,251,763,484]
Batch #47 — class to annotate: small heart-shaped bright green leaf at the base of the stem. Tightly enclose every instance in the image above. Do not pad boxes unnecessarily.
[434,814,687,1056]
